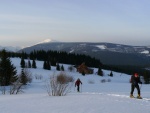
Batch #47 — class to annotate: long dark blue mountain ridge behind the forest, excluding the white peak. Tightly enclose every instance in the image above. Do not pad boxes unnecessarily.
[18,41,150,65]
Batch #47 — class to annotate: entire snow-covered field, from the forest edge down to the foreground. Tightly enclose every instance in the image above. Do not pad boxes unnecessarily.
[0,58,150,113]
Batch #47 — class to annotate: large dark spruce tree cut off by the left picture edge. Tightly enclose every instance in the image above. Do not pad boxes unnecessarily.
[0,50,18,86]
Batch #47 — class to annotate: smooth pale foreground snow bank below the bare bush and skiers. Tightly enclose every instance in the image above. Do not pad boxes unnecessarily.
[0,92,150,113]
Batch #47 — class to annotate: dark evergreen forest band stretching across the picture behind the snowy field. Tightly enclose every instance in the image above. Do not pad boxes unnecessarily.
[1,50,150,84]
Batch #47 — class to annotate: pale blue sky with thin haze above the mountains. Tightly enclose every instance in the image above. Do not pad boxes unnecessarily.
[0,0,150,46]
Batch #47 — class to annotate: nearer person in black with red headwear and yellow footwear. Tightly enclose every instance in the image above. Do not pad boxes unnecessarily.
[130,73,142,99]
